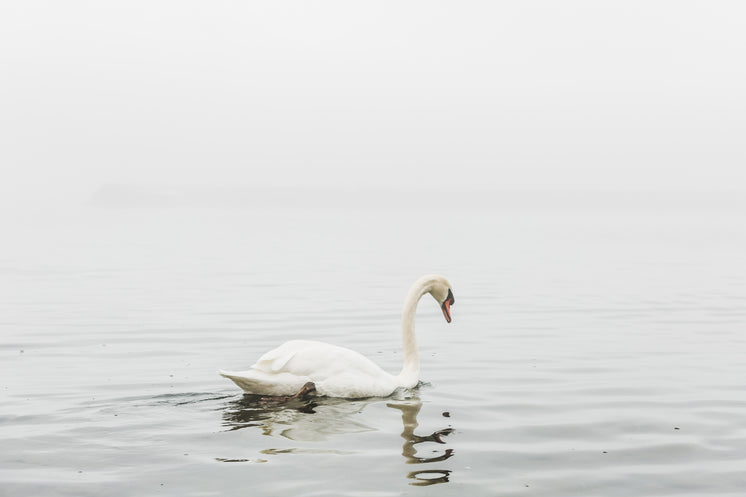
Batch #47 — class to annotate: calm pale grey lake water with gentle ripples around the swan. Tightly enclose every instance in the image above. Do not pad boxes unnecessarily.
[0,188,746,497]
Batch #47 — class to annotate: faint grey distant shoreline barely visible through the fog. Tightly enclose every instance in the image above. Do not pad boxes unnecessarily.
[87,184,746,212]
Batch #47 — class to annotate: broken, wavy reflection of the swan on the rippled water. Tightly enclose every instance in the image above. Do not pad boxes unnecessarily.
[223,392,453,486]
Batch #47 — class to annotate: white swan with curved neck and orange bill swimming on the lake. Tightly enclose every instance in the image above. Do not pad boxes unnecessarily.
[219,275,455,398]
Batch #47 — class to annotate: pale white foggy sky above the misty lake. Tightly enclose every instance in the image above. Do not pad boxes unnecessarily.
[0,1,746,212]
